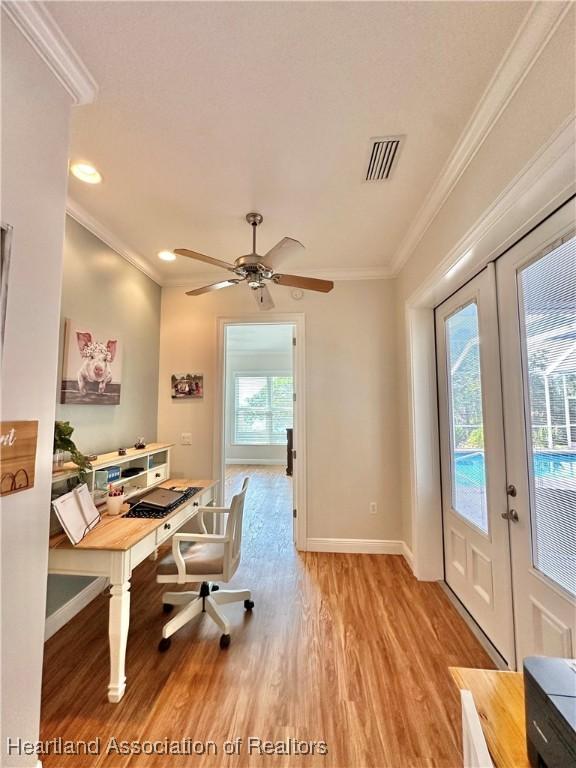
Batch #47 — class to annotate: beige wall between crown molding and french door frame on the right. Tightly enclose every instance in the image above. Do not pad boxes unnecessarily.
[396,9,576,556]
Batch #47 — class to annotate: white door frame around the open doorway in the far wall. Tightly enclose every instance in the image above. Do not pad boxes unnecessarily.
[213,312,308,551]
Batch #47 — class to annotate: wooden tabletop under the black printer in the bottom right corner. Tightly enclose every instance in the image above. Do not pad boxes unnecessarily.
[450,667,530,768]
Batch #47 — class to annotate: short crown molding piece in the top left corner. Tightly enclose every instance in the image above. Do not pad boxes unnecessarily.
[2,0,98,104]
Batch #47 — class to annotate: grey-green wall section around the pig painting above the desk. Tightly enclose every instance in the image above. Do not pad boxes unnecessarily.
[56,216,161,453]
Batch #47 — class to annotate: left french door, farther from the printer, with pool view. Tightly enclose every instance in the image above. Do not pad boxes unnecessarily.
[436,264,515,667]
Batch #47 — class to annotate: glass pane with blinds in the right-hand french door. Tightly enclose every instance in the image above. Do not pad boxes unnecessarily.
[518,238,576,595]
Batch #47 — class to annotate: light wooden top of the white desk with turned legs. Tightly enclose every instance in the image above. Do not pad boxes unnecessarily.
[48,478,217,551]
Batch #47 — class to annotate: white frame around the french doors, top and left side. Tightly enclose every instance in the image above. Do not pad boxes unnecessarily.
[404,117,576,581]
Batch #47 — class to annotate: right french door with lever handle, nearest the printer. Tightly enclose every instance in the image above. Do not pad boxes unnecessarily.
[496,205,576,659]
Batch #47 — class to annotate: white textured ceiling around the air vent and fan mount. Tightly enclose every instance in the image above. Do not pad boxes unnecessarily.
[49,0,528,283]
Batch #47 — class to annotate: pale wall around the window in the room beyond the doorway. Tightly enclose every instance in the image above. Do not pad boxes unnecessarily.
[225,352,292,465]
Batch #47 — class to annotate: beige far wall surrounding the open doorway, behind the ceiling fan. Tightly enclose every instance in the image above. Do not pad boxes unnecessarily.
[158,280,401,539]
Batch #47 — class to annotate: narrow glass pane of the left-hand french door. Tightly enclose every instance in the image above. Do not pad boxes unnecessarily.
[446,302,488,533]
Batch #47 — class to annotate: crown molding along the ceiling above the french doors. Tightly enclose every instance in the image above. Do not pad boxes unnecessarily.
[391,2,572,274]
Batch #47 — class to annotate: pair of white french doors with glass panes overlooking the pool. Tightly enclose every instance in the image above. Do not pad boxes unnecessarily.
[436,204,576,668]
